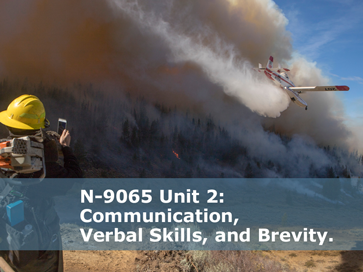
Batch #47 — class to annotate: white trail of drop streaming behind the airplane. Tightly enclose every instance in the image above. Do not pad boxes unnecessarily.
[110,0,289,117]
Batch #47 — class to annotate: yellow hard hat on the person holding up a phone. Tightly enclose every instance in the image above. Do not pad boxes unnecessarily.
[0,94,49,130]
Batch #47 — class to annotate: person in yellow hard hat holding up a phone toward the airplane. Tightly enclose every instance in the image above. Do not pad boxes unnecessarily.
[0,95,82,272]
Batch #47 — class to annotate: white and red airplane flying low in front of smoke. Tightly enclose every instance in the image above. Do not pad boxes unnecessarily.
[255,56,349,110]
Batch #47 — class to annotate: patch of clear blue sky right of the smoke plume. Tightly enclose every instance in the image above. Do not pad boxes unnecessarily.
[274,0,363,123]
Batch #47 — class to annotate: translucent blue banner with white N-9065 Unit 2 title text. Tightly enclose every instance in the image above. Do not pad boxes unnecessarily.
[0,178,363,250]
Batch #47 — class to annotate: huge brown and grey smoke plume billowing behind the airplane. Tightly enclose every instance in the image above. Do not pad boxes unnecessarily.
[0,0,360,164]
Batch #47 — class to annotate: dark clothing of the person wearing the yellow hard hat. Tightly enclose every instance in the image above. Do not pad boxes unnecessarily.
[0,131,82,272]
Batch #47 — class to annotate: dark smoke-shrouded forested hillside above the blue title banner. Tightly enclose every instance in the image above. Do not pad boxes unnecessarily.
[0,80,362,182]
